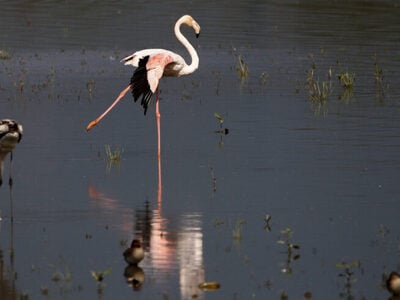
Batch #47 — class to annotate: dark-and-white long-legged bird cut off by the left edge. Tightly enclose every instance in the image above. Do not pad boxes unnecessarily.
[0,119,23,185]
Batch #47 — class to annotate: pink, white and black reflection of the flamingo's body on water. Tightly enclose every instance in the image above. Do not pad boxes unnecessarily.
[134,195,204,299]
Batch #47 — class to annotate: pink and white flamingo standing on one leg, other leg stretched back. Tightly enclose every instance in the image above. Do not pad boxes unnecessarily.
[86,15,200,158]
